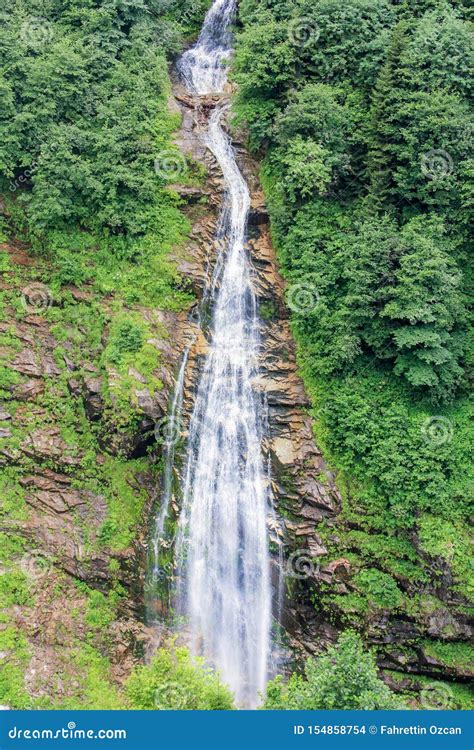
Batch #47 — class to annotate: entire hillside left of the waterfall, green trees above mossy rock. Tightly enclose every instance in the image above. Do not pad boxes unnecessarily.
[0,0,207,708]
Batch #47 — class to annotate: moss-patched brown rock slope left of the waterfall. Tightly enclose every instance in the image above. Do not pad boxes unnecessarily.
[0,242,194,708]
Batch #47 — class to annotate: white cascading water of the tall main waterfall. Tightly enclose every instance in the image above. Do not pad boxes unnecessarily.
[177,0,271,707]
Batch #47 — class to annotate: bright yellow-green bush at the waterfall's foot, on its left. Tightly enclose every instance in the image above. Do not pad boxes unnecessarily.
[126,642,234,711]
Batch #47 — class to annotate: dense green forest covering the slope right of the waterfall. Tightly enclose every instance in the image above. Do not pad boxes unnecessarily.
[234,0,473,620]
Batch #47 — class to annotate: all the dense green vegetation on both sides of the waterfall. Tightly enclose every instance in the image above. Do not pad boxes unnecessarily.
[0,0,474,709]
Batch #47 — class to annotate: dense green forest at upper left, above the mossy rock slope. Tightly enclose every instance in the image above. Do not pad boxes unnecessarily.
[0,0,210,303]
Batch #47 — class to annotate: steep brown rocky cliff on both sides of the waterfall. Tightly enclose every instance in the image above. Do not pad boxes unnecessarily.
[0,70,471,707]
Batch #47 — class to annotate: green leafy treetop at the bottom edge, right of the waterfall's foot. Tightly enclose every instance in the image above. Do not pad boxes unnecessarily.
[264,630,404,711]
